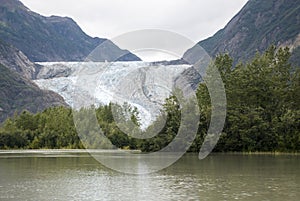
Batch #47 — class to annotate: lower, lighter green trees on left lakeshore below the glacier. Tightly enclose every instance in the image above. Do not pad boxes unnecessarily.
[0,104,138,149]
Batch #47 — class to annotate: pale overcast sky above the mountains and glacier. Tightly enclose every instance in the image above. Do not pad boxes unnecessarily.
[21,0,247,60]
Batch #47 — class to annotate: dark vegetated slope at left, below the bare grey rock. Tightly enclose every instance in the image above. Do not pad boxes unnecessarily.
[0,64,67,122]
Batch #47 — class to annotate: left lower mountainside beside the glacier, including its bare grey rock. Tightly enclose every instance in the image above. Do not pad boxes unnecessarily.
[0,41,67,123]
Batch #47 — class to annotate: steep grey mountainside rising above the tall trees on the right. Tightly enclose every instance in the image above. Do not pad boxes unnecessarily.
[183,0,300,66]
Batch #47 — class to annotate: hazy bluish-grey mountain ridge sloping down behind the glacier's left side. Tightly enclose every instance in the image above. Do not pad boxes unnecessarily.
[0,0,140,62]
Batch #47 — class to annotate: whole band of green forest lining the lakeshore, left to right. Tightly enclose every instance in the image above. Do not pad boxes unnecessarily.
[0,46,300,152]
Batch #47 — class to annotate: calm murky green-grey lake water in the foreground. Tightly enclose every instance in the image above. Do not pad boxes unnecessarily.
[0,152,300,201]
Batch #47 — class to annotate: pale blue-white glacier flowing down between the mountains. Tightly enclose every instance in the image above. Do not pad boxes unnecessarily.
[34,61,191,129]
